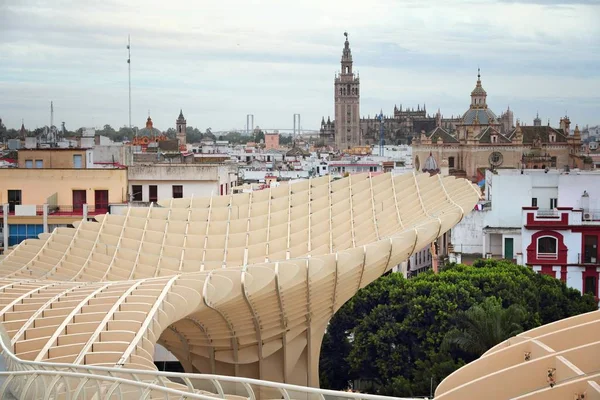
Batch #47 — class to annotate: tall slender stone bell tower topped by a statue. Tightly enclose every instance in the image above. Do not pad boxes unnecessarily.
[334,32,361,150]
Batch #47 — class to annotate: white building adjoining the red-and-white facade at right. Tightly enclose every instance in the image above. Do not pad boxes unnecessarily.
[451,169,600,264]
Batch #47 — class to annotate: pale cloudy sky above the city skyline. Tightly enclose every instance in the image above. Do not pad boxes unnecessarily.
[0,0,600,131]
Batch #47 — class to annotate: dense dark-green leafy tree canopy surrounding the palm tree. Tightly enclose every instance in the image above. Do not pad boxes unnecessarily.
[320,260,598,396]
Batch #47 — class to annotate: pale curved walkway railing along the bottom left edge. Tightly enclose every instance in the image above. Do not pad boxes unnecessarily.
[0,326,417,400]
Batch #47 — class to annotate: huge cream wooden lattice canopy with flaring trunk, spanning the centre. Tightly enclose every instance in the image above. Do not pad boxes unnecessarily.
[0,174,480,394]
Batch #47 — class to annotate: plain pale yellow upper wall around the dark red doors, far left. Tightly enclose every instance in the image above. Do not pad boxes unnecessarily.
[0,169,127,205]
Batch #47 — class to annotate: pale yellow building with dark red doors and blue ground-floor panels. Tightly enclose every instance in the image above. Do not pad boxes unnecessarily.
[0,166,127,247]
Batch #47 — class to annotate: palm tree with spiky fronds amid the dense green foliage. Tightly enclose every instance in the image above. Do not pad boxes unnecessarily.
[442,296,527,357]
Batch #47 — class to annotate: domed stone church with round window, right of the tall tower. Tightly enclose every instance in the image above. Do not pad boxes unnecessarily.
[413,74,581,181]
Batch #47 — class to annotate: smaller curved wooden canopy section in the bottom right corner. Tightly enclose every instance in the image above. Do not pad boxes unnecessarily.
[435,311,600,400]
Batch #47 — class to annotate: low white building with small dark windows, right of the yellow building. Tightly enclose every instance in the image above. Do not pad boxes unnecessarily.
[127,163,238,203]
